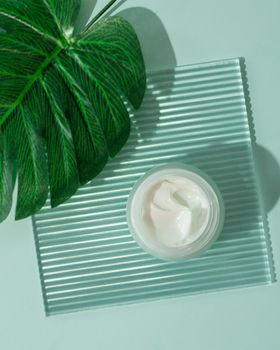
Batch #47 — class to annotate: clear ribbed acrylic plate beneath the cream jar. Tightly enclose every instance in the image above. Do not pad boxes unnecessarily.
[33,59,275,315]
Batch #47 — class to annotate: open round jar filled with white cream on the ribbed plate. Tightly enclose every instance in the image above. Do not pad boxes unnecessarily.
[127,164,225,260]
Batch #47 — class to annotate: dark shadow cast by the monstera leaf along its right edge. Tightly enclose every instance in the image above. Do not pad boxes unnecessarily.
[91,7,176,185]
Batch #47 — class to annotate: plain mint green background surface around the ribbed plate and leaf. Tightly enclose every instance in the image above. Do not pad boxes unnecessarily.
[0,0,280,350]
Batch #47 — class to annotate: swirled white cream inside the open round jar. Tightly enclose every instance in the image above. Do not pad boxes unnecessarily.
[147,176,210,247]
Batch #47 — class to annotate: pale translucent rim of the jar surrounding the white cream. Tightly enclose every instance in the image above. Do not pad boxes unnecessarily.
[127,163,224,260]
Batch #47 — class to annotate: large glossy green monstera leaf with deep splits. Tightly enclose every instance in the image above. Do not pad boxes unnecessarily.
[0,0,146,221]
